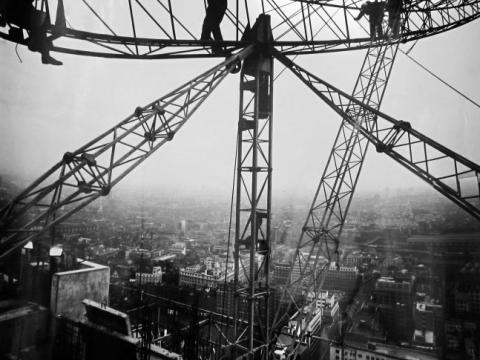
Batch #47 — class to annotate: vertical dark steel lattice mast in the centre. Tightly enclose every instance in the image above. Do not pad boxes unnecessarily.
[234,16,273,359]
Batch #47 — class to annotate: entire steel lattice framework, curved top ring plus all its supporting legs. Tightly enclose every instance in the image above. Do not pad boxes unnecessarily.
[0,0,480,358]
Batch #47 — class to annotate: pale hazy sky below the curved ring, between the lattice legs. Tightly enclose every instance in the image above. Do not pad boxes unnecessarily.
[0,6,480,202]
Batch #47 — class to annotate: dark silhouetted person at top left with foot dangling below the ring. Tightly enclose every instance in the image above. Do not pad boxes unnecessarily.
[0,0,62,65]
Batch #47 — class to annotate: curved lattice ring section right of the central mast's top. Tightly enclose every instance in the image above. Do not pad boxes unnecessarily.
[267,0,480,55]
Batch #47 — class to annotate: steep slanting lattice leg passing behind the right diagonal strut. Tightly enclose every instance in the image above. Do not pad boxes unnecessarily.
[273,39,398,354]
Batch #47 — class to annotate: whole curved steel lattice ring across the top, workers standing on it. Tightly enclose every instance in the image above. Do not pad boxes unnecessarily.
[0,0,480,59]
